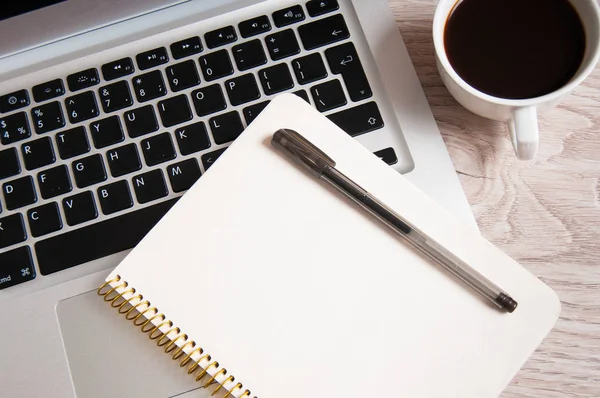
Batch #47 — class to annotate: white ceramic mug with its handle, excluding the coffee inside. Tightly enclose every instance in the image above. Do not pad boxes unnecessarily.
[433,0,600,160]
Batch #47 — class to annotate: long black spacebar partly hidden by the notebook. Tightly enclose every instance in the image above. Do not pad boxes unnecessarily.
[35,199,177,275]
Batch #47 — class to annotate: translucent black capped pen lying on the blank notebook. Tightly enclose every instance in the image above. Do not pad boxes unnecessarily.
[271,129,518,312]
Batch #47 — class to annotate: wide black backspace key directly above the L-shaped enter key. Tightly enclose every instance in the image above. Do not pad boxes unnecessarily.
[298,14,350,50]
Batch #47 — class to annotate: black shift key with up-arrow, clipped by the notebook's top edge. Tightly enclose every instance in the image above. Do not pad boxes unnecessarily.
[327,102,384,137]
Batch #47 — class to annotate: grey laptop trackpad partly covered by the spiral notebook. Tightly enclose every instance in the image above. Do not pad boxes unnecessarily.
[57,291,212,398]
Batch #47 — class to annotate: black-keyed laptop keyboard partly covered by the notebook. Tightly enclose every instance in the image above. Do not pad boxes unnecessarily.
[0,0,397,289]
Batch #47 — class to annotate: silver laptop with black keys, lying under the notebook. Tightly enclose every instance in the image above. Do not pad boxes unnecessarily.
[0,0,476,398]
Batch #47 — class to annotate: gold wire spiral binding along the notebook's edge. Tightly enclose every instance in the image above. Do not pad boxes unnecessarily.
[97,275,256,398]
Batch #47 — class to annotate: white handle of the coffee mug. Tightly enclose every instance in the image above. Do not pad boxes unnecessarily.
[508,106,540,160]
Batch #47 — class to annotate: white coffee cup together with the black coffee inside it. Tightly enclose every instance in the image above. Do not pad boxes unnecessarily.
[433,0,600,160]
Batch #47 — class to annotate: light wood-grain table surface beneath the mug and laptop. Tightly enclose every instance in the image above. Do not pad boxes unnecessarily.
[388,0,600,398]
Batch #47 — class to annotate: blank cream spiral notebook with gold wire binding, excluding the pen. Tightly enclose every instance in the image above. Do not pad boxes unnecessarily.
[98,95,560,398]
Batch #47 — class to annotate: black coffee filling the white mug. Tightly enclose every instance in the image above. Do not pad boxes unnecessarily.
[444,0,585,99]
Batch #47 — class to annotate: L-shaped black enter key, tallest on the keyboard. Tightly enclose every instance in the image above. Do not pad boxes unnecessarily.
[325,43,373,102]
